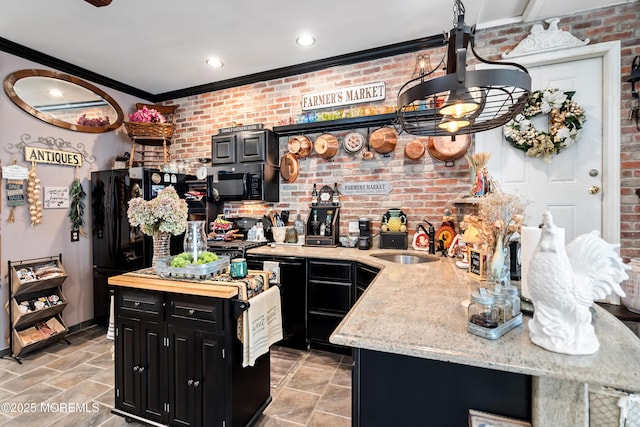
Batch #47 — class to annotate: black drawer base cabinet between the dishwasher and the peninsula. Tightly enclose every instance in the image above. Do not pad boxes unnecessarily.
[307,259,356,348]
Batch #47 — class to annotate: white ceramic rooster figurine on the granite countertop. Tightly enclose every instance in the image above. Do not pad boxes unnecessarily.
[528,211,629,355]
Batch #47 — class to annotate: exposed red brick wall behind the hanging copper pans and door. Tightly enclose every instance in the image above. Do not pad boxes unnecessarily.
[168,2,640,257]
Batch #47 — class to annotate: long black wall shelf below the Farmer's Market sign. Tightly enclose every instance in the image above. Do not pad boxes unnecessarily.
[273,113,397,136]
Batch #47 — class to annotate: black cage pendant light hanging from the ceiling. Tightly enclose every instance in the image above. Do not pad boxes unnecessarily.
[398,0,531,136]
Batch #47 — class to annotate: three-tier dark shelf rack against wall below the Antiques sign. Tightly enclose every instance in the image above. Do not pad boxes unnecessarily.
[8,254,69,363]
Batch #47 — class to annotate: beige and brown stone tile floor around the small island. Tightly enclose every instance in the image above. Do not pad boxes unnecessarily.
[0,326,351,427]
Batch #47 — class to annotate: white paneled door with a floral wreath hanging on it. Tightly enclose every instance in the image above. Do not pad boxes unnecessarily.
[475,57,604,242]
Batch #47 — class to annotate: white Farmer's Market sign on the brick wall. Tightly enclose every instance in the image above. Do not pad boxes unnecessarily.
[302,82,386,111]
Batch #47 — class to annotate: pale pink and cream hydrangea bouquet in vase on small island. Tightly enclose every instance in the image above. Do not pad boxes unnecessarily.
[127,186,189,236]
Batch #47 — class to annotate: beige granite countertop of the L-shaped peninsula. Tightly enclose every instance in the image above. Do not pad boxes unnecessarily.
[249,245,640,392]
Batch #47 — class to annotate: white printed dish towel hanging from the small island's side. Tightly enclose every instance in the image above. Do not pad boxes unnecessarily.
[242,286,283,368]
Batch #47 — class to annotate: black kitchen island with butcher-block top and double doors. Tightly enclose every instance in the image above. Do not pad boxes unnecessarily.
[109,271,271,427]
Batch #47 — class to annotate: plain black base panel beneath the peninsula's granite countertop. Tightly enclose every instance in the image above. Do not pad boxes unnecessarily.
[352,349,532,427]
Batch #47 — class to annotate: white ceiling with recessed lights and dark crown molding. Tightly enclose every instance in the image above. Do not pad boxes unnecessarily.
[0,0,636,94]
